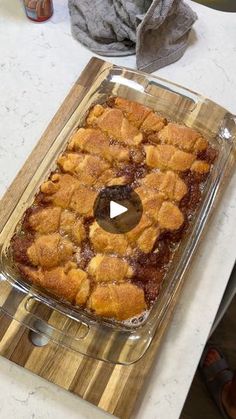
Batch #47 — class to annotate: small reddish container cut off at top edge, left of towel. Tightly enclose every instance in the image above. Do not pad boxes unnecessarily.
[24,0,53,22]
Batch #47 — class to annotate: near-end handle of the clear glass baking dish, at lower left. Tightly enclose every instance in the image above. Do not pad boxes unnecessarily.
[0,276,154,365]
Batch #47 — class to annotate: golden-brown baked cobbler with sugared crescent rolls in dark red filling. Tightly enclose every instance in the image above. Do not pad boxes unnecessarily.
[11,97,217,321]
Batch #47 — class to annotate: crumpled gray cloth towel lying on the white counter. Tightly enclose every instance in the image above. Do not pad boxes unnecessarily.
[69,0,197,73]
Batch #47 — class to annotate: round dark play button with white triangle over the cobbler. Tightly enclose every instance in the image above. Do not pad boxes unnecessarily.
[94,185,143,234]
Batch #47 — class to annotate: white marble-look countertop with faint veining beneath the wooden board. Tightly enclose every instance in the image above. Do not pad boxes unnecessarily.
[0,0,236,419]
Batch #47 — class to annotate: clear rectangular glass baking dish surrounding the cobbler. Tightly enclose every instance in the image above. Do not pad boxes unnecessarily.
[0,62,236,365]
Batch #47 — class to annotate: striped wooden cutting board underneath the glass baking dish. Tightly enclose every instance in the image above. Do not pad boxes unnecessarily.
[0,58,193,419]
